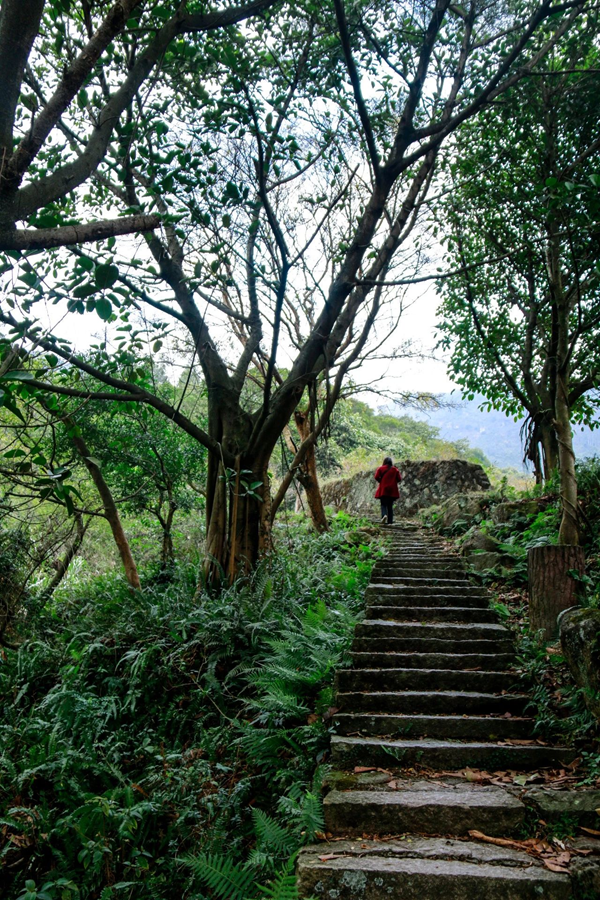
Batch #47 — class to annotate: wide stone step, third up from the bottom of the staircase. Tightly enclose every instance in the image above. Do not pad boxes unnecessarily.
[331,735,576,772]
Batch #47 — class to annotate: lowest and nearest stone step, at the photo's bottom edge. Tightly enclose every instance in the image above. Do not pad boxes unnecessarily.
[297,836,573,900]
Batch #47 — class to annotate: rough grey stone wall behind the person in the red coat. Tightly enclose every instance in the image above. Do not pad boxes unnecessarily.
[322,459,490,516]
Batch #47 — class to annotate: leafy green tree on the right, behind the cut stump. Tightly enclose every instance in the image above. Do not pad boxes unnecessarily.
[440,26,600,544]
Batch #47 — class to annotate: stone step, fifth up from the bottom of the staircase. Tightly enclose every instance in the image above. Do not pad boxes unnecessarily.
[335,690,531,716]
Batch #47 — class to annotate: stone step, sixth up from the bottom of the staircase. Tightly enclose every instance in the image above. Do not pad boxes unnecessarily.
[335,669,519,694]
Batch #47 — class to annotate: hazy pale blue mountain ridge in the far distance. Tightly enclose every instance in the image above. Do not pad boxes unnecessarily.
[397,392,600,470]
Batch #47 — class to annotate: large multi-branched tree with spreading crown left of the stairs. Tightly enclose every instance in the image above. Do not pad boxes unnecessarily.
[0,0,586,571]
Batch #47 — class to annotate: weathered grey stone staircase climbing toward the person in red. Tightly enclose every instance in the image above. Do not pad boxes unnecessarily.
[298,525,575,900]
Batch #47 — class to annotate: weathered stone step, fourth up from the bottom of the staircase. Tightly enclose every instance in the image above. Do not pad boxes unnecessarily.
[333,707,535,741]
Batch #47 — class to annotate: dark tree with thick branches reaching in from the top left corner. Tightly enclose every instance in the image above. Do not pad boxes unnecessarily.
[0,0,274,252]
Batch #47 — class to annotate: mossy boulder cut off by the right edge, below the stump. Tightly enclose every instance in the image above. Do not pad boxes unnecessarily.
[559,607,600,719]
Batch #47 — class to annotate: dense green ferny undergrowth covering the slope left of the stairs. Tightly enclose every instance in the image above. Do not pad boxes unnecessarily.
[0,517,379,900]
